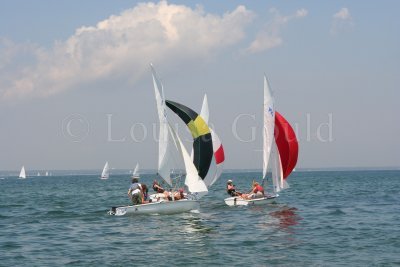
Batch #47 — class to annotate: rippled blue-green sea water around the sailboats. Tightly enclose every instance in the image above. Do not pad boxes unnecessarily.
[0,171,400,266]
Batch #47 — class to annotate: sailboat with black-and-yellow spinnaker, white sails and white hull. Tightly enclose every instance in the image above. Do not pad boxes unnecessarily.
[110,66,220,216]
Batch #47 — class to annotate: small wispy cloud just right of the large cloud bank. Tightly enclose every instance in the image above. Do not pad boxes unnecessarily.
[247,8,308,53]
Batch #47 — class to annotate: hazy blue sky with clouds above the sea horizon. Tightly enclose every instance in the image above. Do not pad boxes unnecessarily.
[0,0,400,173]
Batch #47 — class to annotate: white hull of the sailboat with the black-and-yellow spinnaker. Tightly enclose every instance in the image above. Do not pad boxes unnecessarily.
[109,199,200,216]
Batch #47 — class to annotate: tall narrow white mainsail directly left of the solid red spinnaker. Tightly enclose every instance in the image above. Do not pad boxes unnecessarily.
[263,75,275,179]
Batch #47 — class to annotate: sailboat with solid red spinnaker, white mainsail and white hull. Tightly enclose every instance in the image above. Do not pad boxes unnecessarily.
[225,75,299,206]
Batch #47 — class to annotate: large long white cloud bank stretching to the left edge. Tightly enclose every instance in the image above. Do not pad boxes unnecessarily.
[0,1,253,100]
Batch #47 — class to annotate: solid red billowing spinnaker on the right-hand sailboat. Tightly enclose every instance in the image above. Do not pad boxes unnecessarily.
[274,111,299,179]
